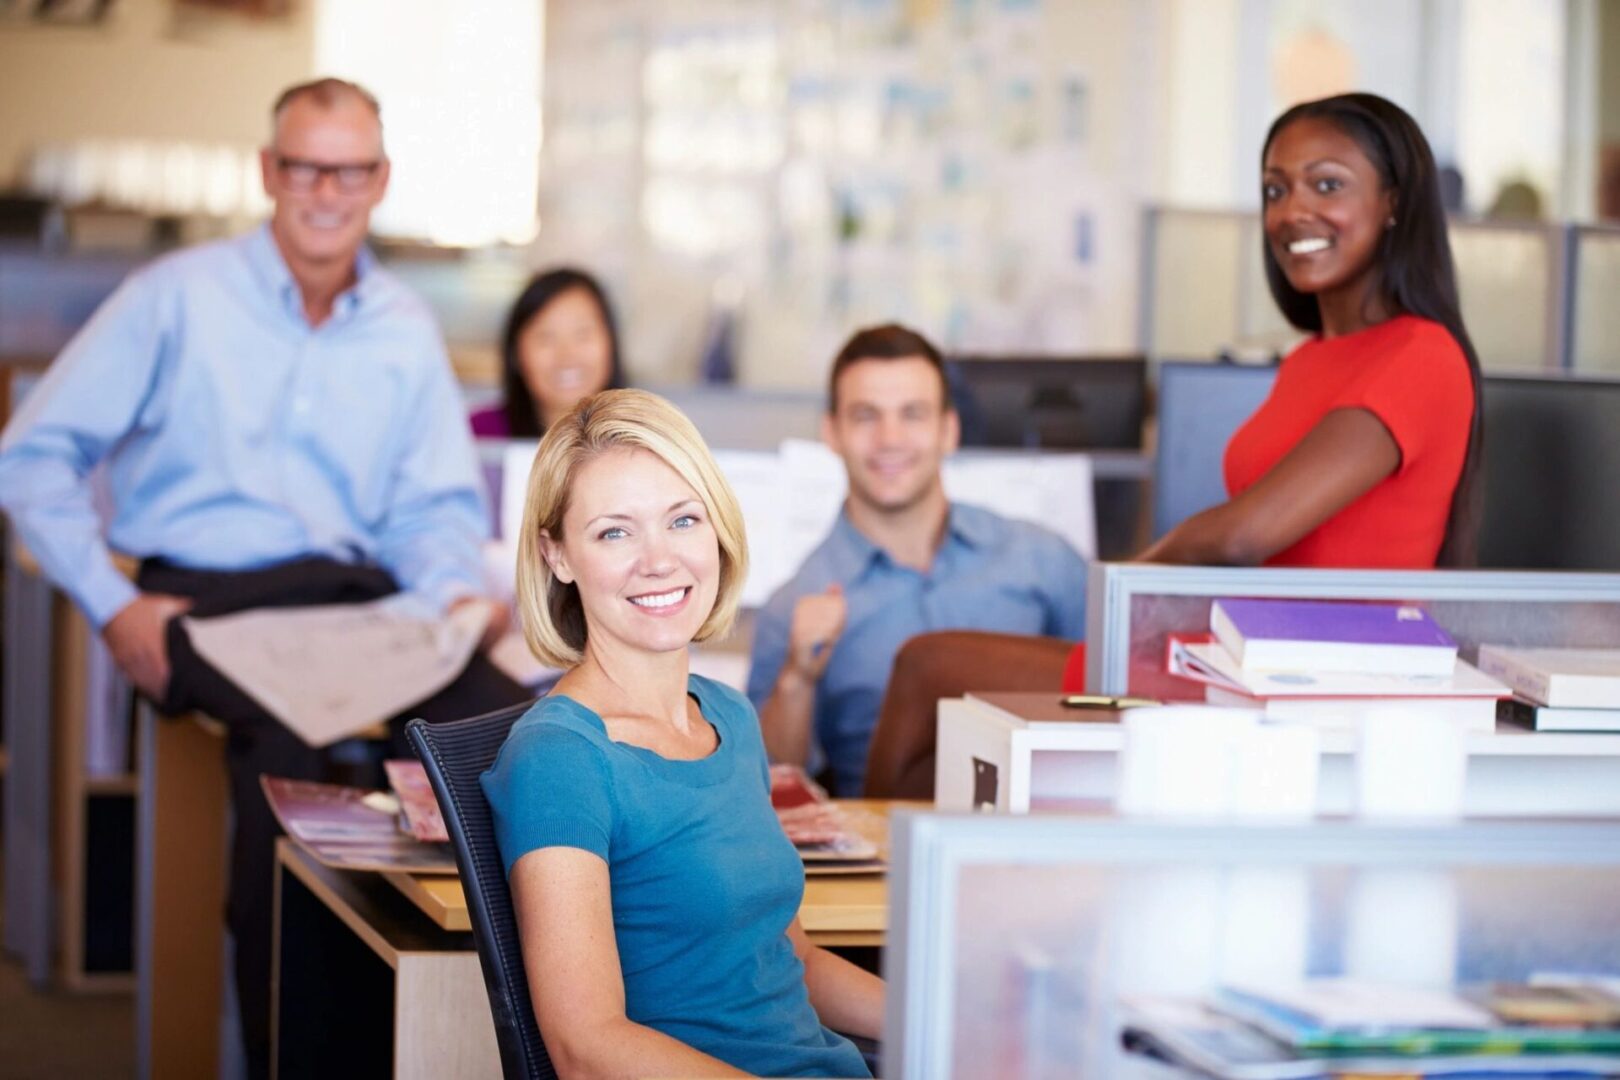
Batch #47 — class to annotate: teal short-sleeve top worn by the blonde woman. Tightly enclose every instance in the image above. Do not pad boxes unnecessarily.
[483,675,870,1077]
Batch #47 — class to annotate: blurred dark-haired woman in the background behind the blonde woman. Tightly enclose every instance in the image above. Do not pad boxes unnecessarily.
[471,267,624,439]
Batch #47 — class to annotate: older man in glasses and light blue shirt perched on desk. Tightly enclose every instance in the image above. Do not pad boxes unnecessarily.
[0,79,528,1075]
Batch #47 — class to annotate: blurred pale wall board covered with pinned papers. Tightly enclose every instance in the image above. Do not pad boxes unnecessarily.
[536,0,1163,387]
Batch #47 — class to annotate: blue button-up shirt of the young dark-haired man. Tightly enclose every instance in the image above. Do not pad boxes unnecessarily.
[748,504,1085,797]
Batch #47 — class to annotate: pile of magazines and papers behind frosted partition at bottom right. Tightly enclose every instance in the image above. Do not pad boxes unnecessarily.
[1123,978,1620,1080]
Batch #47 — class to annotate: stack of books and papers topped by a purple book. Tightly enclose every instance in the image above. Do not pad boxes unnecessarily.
[1168,599,1510,732]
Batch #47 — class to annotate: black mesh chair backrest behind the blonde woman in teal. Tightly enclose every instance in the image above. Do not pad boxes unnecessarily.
[405,703,557,1080]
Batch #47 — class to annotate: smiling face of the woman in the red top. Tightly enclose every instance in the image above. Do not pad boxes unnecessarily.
[1260,117,1395,298]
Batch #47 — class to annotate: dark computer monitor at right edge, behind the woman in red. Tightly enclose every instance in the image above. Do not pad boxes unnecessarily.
[1479,376,1620,570]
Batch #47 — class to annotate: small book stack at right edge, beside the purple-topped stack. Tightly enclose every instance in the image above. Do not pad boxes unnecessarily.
[1479,644,1620,732]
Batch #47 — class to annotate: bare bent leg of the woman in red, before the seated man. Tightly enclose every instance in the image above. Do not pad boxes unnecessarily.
[863,630,1084,798]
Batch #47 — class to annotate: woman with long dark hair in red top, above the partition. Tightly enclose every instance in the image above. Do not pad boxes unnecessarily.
[1140,94,1481,568]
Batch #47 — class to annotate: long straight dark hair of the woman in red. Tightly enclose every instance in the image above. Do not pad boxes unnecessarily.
[1260,94,1484,567]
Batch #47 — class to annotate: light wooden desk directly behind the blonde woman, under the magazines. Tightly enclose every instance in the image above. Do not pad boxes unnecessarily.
[272,800,927,1077]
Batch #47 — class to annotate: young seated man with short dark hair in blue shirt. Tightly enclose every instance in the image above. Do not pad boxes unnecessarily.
[748,325,1085,797]
